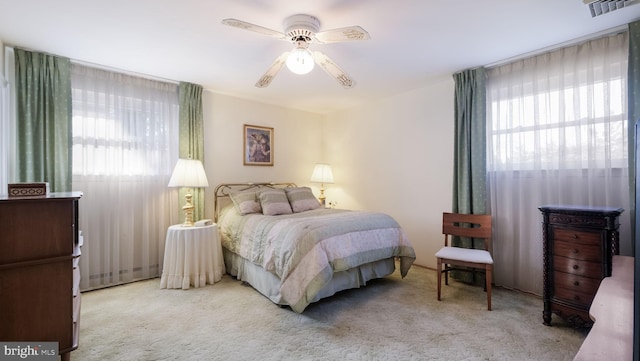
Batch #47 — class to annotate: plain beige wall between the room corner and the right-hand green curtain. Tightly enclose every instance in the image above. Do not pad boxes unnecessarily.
[323,77,454,268]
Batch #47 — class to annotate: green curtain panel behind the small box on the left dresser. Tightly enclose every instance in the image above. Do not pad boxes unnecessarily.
[14,49,72,192]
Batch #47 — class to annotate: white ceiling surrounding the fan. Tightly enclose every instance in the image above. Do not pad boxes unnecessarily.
[0,0,640,114]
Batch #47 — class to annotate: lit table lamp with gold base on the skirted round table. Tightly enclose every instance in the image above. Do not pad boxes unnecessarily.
[169,159,209,227]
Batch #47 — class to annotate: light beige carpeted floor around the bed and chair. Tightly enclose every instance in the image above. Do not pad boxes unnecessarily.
[71,266,585,361]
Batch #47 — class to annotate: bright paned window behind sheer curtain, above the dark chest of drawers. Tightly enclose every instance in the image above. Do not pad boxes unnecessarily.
[490,78,627,170]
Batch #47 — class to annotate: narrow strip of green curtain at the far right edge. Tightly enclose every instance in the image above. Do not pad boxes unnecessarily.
[627,21,640,250]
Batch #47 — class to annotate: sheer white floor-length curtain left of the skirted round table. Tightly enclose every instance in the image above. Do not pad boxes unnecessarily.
[71,64,179,290]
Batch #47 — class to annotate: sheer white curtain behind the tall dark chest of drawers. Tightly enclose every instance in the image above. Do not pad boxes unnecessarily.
[487,32,630,294]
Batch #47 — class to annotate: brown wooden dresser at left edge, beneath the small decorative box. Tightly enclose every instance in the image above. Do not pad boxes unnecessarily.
[0,192,82,360]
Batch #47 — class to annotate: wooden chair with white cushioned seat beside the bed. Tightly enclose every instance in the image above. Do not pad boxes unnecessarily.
[436,213,493,311]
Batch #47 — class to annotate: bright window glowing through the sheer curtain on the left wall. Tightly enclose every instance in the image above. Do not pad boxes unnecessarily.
[72,65,178,175]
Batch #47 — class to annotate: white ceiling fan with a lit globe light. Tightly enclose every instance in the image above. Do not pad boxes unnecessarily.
[222,14,369,89]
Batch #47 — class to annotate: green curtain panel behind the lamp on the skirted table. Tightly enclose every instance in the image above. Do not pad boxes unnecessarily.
[178,82,205,221]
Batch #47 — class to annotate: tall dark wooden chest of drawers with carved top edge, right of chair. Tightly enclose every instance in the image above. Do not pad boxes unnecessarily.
[539,206,623,327]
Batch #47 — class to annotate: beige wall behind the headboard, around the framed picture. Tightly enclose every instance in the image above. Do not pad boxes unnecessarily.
[202,91,323,218]
